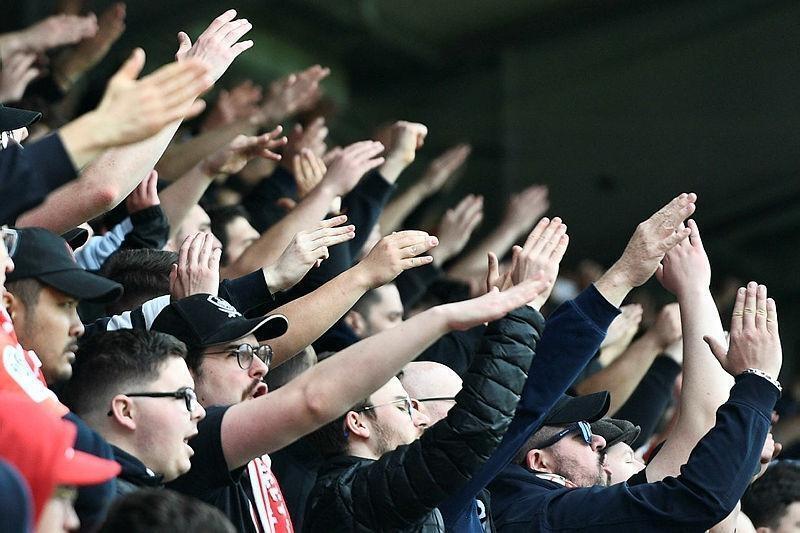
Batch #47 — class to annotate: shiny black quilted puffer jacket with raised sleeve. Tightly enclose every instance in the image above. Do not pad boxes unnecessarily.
[303,307,544,533]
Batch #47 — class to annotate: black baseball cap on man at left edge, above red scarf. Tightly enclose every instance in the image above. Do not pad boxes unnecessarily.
[6,228,122,303]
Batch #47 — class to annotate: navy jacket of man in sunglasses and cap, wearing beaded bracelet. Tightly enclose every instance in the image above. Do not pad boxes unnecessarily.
[490,374,778,533]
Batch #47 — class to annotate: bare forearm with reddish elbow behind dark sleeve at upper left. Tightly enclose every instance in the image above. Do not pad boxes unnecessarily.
[19,121,180,233]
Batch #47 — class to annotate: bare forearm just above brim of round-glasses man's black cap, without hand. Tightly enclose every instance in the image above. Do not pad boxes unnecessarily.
[270,265,370,365]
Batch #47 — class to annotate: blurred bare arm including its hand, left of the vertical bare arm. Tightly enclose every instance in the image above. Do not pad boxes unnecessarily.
[575,303,681,416]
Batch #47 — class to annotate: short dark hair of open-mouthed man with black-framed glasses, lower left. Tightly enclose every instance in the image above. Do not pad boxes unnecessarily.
[62,329,186,416]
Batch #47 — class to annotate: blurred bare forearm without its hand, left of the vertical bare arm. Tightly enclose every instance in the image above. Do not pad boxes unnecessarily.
[575,333,662,416]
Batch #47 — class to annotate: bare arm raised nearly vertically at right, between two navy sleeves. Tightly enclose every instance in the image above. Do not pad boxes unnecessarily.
[647,220,736,480]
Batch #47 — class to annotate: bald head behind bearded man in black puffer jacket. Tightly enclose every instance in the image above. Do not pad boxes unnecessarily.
[400,361,461,424]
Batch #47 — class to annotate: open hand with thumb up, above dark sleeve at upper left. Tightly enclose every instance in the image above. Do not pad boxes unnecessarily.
[91,48,211,146]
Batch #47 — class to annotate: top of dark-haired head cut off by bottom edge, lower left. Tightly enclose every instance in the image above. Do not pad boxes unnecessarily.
[99,489,236,533]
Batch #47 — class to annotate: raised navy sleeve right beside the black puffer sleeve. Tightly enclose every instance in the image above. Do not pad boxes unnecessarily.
[439,285,620,531]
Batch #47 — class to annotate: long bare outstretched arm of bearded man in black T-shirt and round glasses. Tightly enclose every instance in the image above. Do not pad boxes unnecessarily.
[222,281,542,469]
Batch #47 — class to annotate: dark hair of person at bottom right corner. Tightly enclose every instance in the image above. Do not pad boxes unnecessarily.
[742,461,800,529]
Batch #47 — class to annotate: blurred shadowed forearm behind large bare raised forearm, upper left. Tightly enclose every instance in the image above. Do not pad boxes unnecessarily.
[156,120,256,180]
